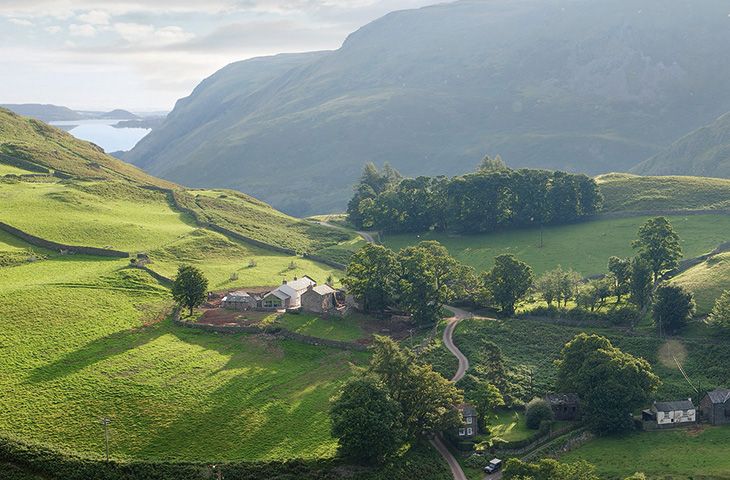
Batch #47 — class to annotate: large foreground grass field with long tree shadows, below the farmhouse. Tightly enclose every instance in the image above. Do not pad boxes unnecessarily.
[0,256,365,460]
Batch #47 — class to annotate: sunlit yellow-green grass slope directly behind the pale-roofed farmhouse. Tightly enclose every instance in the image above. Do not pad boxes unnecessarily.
[149,229,343,290]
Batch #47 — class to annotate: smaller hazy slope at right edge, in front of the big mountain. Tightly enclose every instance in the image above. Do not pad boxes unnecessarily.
[632,113,730,178]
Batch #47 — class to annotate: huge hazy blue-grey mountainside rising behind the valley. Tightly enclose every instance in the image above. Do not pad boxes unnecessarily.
[125,0,730,214]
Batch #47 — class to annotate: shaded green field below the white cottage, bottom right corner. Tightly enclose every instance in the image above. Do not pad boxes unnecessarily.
[561,426,730,480]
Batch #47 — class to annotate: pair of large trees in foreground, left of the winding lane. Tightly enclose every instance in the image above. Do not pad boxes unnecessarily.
[330,337,464,463]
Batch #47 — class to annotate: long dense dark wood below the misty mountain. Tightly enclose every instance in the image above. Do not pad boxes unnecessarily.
[347,160,603,233]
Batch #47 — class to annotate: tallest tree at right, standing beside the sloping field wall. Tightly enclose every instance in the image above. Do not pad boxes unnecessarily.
[633,217,682,282]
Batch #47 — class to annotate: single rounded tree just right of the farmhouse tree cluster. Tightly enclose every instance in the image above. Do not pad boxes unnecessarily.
[482,254,532,315]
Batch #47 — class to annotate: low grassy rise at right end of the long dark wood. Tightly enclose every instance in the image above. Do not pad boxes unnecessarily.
[596,173,730,212]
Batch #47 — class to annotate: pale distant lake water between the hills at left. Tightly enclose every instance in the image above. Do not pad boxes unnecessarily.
[51,120,150,152]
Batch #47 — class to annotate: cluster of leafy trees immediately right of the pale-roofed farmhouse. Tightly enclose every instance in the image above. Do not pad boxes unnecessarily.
[342,241,476,324]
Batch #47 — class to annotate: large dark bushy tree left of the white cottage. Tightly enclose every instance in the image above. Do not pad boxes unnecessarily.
[556,333,661,434]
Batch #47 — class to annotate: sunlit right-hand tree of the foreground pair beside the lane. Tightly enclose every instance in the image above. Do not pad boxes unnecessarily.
[368,336,464,438]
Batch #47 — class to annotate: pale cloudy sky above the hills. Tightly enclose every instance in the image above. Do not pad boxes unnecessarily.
[0,0,439,110]
